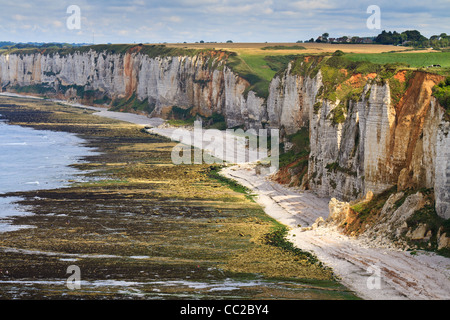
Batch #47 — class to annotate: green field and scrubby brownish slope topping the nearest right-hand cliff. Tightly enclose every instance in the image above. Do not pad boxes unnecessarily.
[291,51,450,114]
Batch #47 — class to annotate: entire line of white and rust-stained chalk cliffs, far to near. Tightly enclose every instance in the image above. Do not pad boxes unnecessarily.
[0,48,450,218]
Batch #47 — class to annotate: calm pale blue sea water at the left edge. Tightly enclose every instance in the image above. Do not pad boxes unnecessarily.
[0,115,92,232]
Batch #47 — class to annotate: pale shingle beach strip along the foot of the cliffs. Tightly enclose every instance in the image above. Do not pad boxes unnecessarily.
[3,95,450,300]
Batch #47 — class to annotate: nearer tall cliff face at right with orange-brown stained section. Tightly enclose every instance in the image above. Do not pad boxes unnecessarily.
[267,64,450,219]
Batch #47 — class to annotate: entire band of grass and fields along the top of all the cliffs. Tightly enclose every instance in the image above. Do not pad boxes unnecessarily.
[0,44,450,102]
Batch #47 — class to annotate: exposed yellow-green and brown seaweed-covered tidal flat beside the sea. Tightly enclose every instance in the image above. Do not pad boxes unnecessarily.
[0,98,348,300]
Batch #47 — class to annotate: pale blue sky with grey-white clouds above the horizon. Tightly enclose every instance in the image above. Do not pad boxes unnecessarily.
[0,0,450,44]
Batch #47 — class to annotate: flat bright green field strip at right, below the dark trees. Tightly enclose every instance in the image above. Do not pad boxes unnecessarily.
[345,52,450,68]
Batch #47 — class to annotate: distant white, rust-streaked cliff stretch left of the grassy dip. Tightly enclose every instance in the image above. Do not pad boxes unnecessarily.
[0,50,266,128]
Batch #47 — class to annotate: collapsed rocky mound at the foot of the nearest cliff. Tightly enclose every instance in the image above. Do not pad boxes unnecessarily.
[326,192,450,250]
